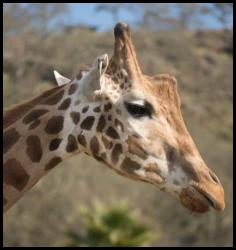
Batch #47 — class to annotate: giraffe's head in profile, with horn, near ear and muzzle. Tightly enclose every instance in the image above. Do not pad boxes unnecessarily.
[55,23,225,213]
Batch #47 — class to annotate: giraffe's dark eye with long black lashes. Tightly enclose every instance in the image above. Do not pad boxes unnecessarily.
[125,102,153,118]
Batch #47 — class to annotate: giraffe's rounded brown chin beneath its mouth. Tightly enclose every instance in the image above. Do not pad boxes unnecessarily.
[179,188,210,213]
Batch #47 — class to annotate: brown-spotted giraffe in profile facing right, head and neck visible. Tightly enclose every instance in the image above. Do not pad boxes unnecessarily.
[3,22,225,213]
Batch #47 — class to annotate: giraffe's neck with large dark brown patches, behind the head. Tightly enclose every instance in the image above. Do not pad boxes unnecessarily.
[3,83,96,211]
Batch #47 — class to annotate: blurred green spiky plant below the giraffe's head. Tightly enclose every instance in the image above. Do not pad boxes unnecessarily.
[63,203,154,247]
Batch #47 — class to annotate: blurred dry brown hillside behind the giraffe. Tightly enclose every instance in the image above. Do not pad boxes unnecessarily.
[3,2,233,246]
